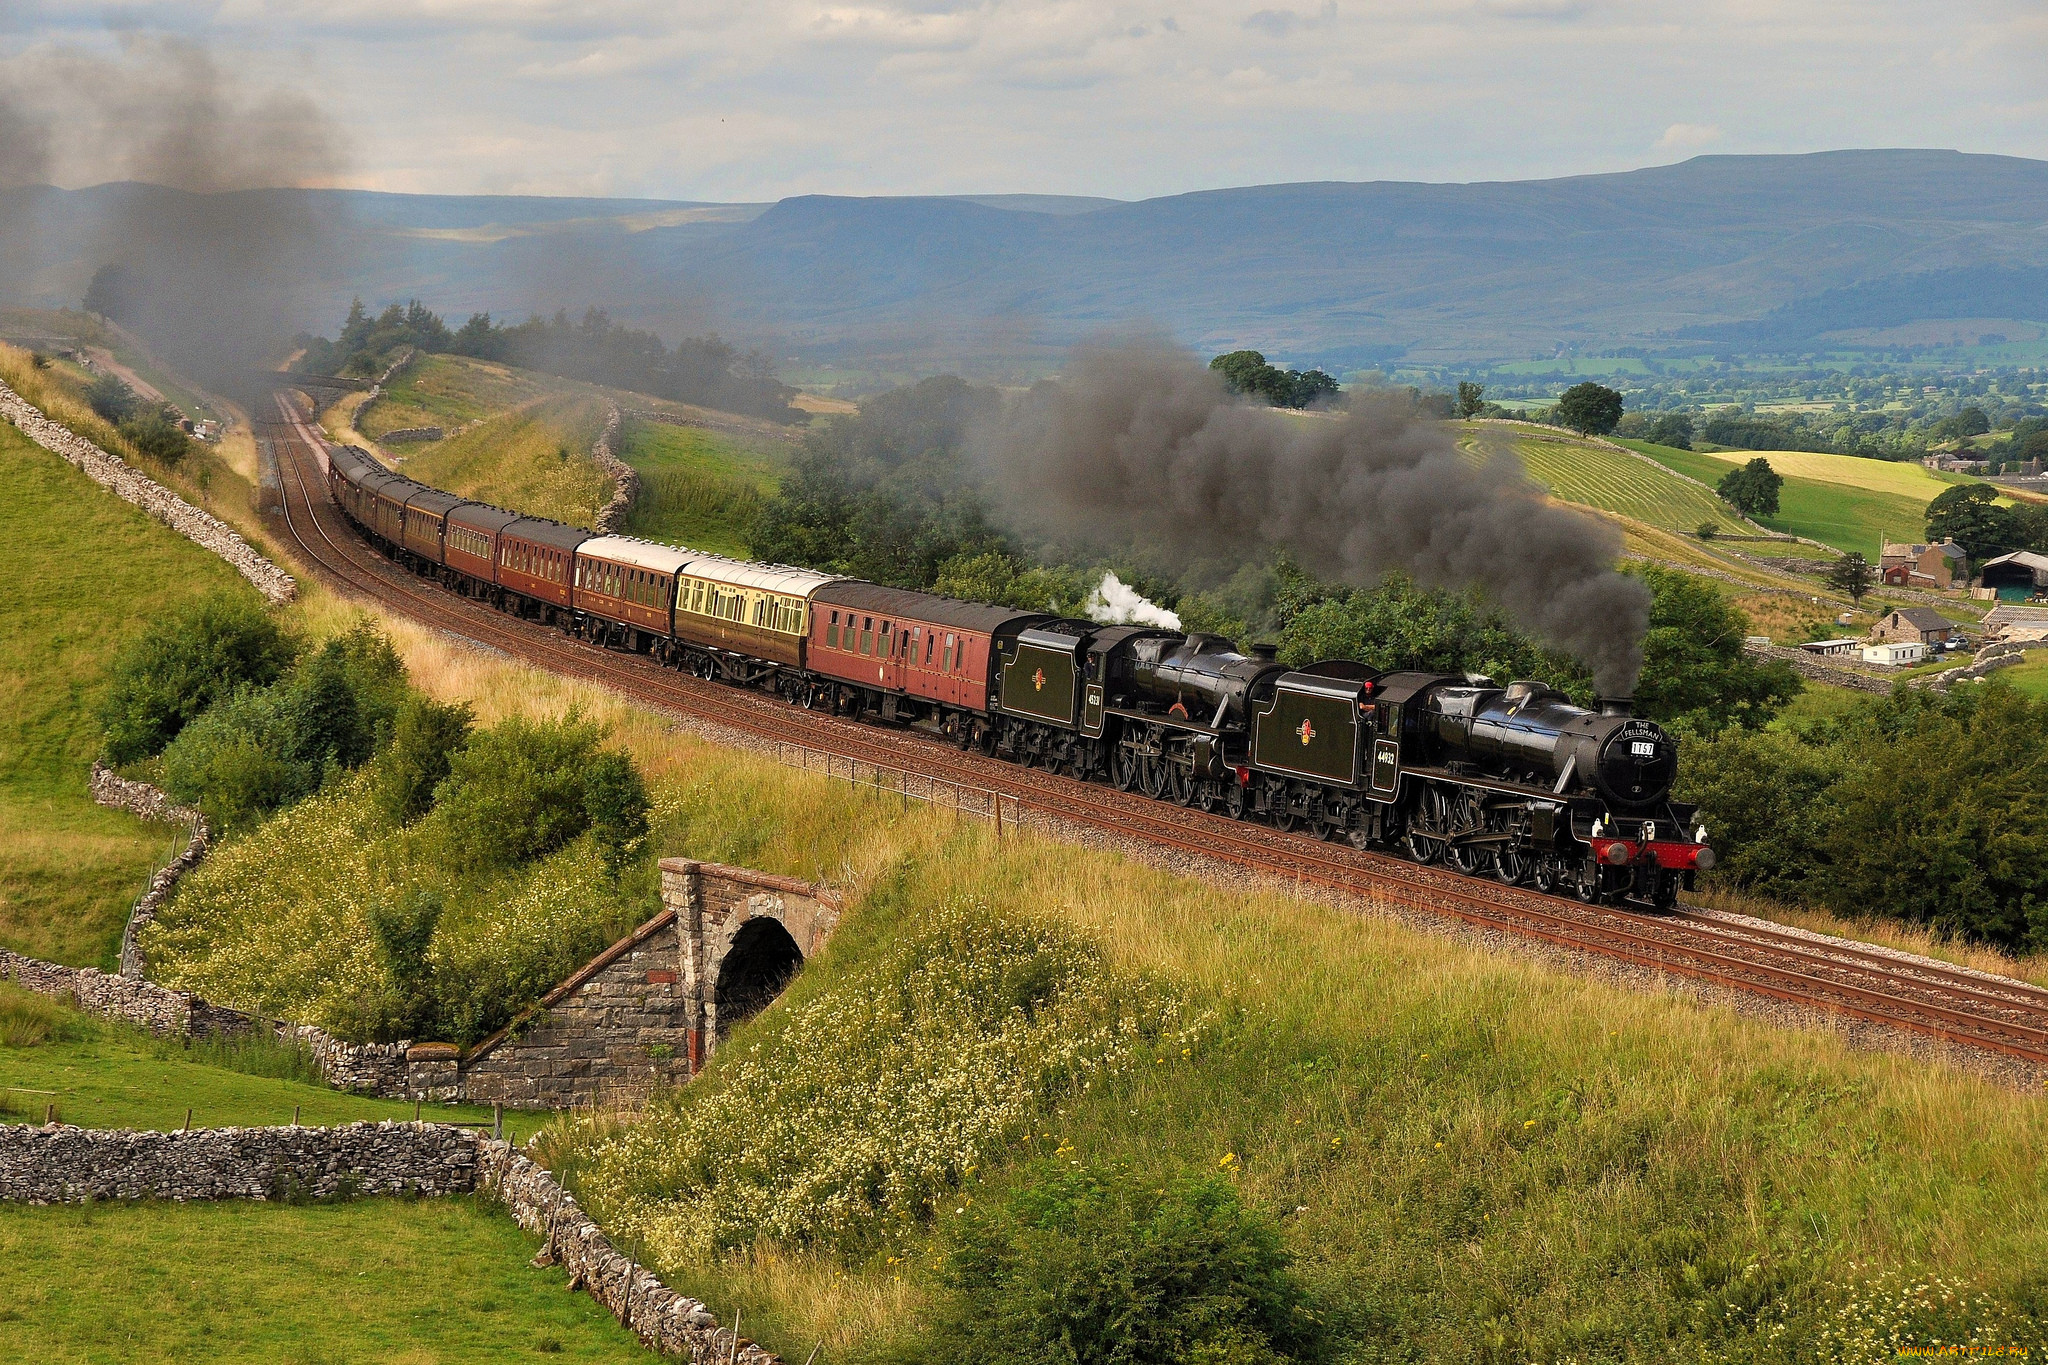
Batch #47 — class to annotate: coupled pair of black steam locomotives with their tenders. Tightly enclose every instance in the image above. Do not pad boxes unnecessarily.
[993,620,1714,907]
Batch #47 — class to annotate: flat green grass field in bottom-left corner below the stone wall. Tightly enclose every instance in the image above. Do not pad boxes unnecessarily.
[0,1197,651,1365]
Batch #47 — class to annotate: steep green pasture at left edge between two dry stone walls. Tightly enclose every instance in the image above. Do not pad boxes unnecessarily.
[0,424,256,968]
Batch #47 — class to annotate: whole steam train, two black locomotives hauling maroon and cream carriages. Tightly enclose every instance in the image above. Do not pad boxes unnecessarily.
[328,446,1714,909]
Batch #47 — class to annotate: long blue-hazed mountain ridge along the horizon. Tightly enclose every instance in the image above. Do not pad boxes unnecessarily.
[0,151,2048,375]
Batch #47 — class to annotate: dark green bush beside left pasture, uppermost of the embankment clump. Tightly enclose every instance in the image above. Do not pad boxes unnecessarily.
[100,593,297,763]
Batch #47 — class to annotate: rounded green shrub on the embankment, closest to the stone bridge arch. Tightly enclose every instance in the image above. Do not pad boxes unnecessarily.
[432,712,647,872]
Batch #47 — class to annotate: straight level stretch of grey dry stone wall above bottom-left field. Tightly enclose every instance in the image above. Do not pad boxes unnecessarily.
[0,1121,477,1203]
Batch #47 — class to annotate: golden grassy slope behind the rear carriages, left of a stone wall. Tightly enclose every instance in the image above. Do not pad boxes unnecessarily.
[403,393,612,526]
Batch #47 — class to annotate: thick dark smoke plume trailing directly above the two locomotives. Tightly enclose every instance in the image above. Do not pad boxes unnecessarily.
[979,342,1651,696]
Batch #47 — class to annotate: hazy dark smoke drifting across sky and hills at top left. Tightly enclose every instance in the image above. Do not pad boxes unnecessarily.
[0,35,344,387]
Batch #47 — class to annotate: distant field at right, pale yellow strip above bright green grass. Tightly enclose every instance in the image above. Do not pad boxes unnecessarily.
[1626,442,1948,563]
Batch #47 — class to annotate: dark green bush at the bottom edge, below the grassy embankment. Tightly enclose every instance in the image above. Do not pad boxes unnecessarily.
[913,1164,1321,1365]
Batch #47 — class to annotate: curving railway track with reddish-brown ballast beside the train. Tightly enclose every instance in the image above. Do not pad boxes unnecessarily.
[260,399,2048,1070]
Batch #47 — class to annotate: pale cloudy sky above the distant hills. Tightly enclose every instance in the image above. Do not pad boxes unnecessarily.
[0,0,2048,201]
